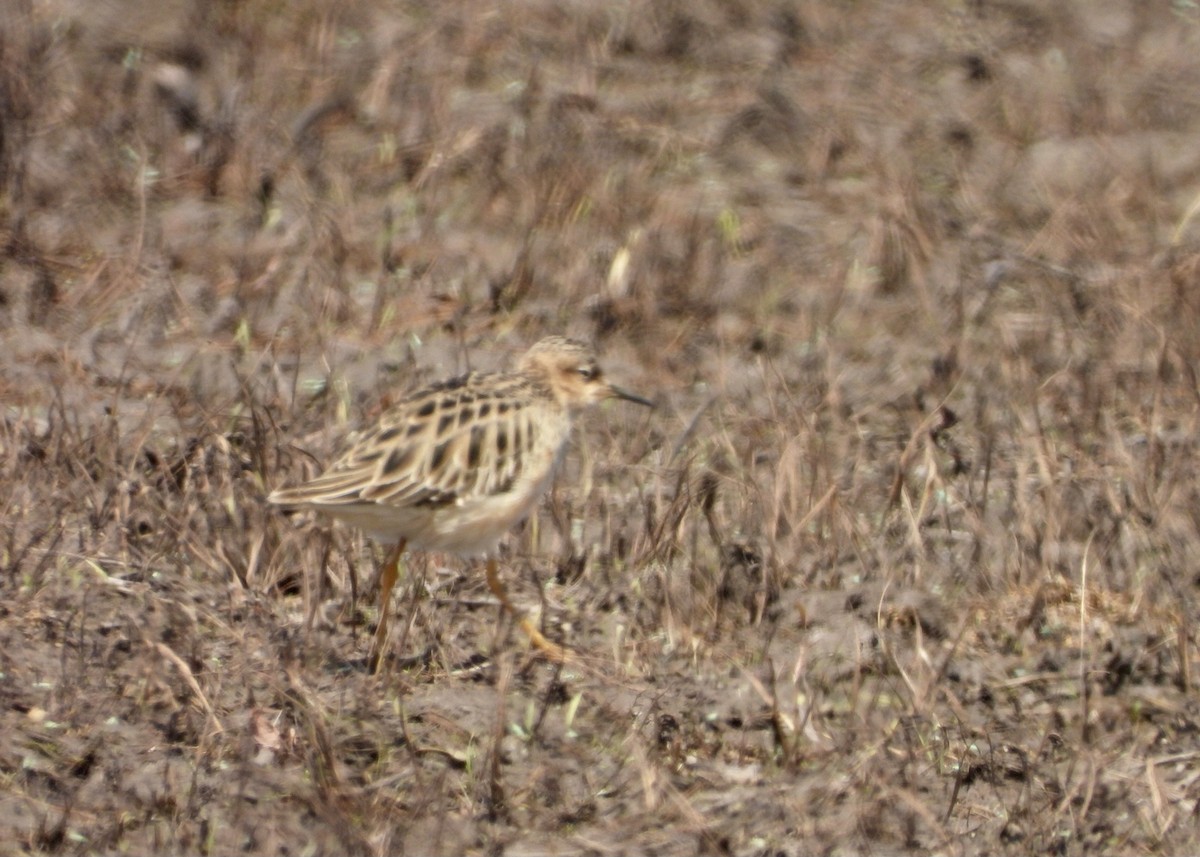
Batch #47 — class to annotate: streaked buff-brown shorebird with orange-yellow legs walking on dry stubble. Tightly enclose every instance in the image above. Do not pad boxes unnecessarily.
[266,336,654,672]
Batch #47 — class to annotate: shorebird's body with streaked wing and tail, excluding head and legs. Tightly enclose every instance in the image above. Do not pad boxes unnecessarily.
[268,364,571,553]
